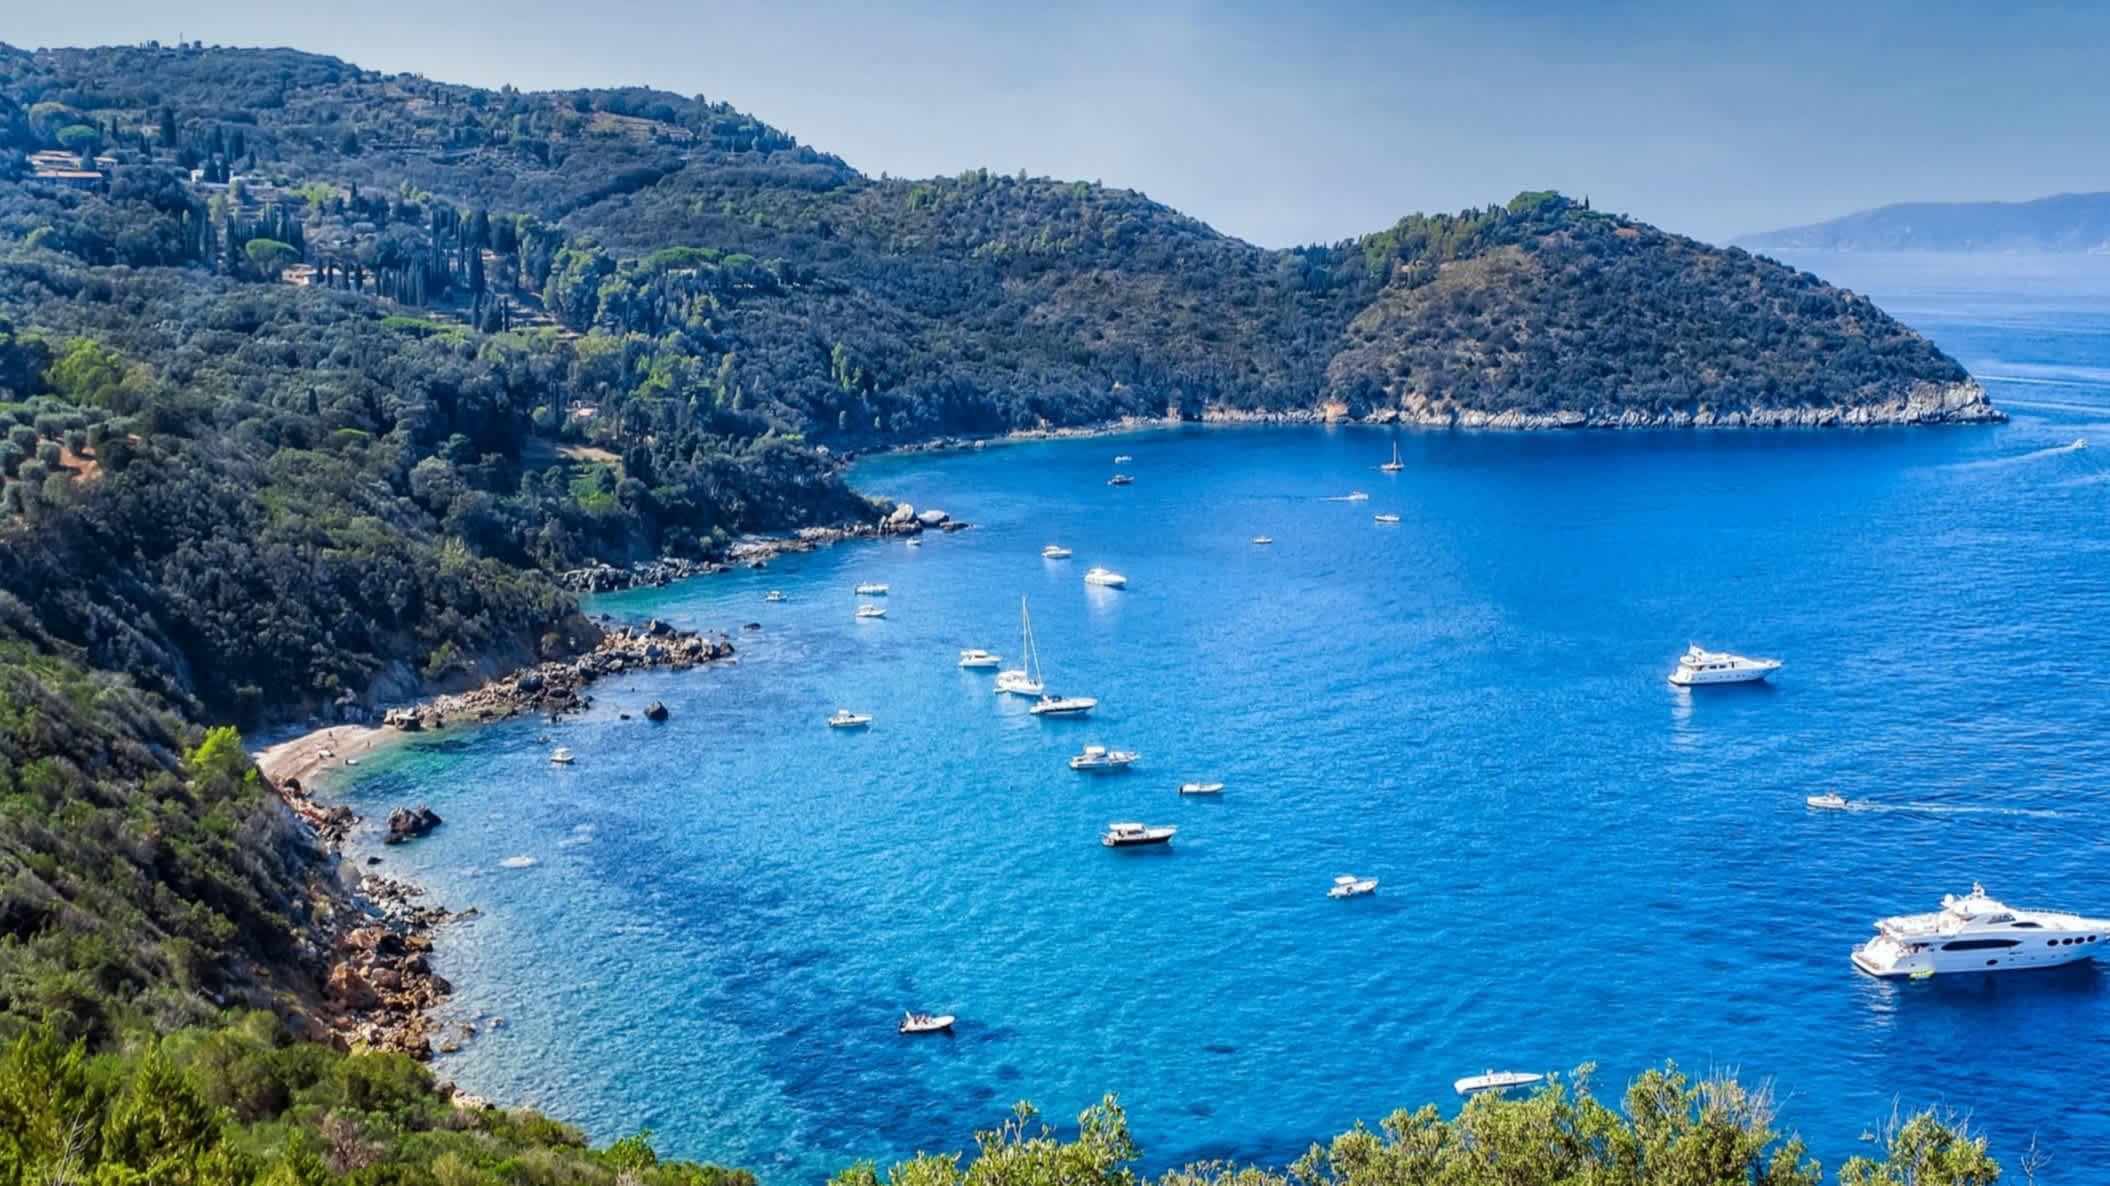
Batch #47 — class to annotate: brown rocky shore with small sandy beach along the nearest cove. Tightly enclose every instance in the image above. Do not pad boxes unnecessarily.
[257,620,732,1050]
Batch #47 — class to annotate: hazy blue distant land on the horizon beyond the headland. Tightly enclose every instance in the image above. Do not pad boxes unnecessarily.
[1737,194,2110,255]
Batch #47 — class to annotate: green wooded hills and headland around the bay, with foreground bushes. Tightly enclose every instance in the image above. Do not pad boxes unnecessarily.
[0,44,1996,1186]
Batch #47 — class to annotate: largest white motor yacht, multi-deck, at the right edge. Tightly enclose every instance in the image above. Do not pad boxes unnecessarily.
[1853,884,2110,979]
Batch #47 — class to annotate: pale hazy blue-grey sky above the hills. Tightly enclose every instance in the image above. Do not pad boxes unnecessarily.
[0,0,2110,247]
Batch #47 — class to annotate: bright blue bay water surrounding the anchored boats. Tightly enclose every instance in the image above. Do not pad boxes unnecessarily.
[329,262,2110,1186]
